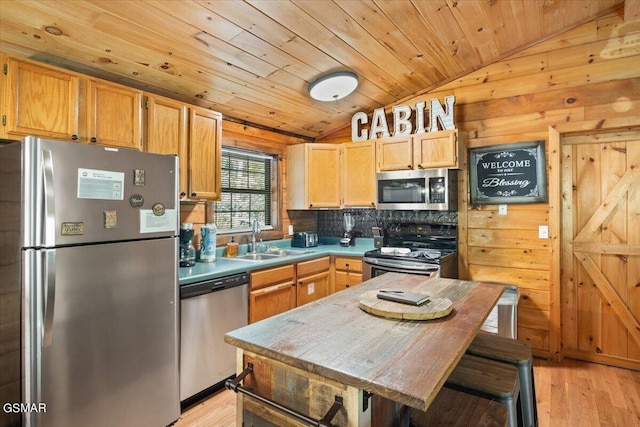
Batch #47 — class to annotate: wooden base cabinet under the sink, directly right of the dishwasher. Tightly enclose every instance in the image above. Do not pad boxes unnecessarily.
[249,264,296,323]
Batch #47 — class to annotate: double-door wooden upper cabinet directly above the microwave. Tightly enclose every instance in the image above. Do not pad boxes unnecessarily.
[376,129,461,172]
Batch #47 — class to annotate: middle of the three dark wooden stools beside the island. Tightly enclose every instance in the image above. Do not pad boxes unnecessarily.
[445,354,520,427]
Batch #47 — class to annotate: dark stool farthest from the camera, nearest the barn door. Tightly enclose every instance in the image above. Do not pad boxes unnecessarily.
[467,332,538,427]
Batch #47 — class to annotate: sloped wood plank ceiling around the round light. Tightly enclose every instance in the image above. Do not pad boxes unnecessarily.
[0,0,632,139]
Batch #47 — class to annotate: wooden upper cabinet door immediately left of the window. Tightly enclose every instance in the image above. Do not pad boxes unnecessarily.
[188,106,222,200]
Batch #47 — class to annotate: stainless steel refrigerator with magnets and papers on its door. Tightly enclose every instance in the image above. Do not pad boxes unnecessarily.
[0,137,180,427]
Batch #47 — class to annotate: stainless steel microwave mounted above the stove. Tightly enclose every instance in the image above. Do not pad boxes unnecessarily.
[376,169,458,211]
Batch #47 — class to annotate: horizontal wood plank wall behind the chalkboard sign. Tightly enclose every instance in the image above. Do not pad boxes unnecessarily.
[322,8,640,358]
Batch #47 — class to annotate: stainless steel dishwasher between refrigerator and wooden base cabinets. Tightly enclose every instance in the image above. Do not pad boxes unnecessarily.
[180,273,249,404]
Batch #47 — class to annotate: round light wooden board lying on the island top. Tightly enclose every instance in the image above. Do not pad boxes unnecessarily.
[358,290,453,320]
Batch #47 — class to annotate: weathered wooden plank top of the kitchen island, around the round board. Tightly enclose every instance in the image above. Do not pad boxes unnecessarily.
[225,273,504,424]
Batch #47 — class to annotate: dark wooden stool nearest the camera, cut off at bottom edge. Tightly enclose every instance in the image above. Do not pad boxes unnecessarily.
[409,388,507,427]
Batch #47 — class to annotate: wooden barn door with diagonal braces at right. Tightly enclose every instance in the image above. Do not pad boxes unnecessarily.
[561,131,640,369]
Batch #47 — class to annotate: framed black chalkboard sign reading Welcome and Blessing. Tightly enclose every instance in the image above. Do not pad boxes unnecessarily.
[469,141,547,204]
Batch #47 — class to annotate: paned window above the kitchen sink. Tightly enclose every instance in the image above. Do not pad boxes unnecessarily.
[213,148,277,233]
